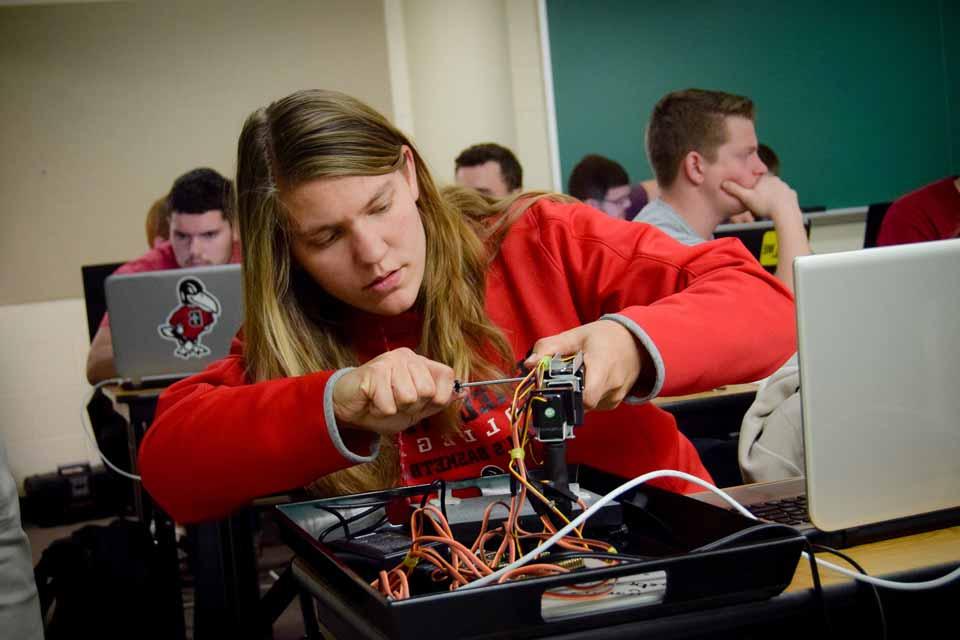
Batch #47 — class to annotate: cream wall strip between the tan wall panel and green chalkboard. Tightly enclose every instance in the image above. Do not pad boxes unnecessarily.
[386,0,552,189]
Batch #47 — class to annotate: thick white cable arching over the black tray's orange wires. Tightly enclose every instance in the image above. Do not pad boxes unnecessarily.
[458,469,960,591]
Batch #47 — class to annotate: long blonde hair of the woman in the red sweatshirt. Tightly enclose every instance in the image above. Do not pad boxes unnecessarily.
[237,90,536,494]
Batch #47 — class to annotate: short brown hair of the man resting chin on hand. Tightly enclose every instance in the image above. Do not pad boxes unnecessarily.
[647,89,754,188]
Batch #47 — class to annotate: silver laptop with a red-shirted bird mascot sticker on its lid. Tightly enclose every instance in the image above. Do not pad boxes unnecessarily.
[104,264,243,386]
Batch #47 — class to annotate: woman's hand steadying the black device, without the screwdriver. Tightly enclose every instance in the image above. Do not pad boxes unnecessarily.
[524,320,649,410]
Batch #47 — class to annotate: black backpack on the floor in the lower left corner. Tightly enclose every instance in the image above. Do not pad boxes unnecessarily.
[34,518,183,640]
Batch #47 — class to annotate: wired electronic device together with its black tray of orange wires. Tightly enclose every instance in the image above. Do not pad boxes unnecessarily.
[278,354,803,638]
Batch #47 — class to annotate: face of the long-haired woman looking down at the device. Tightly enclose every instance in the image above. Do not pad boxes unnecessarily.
[283,147,426,316]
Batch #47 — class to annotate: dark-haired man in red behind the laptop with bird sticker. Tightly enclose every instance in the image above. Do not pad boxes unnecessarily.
[87,168,240,384]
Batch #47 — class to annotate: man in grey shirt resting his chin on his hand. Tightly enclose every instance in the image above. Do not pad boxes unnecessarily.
[634,89,810,291]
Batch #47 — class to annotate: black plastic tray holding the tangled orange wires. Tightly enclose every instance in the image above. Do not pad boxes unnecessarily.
[277,467,805,640]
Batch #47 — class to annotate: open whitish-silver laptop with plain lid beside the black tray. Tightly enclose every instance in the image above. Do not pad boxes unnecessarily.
[692,240,960,546]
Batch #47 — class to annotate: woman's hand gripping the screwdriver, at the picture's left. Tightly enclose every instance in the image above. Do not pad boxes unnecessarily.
[333,348,454,435]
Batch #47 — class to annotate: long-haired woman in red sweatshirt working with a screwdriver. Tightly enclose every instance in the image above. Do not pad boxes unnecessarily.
[140,90,795,522]
